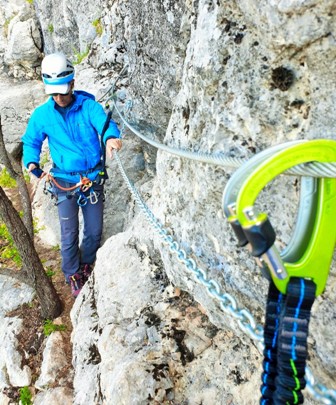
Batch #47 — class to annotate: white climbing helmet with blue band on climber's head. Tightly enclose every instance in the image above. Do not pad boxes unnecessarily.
[41,52,75,94]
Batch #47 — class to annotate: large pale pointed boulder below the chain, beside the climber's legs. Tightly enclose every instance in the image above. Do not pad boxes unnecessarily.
[72,224,264,405]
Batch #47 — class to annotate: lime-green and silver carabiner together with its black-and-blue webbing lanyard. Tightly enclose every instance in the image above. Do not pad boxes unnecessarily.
[223,140,336,405]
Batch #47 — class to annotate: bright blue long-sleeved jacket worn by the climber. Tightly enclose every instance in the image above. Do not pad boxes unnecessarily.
[22,91,120,183]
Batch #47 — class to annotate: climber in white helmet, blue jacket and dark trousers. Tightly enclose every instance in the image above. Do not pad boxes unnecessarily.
[22,53,122,298]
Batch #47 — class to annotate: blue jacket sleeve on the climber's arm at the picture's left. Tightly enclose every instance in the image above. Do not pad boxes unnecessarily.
[21,111,46,167]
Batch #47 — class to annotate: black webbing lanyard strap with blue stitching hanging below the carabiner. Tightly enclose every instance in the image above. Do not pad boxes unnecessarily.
[260,277,316,405]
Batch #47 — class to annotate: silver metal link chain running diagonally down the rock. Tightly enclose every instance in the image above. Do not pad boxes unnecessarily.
[114,151,336,405]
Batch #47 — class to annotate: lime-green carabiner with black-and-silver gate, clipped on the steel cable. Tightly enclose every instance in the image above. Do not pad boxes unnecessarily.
[236,140,336,296]
